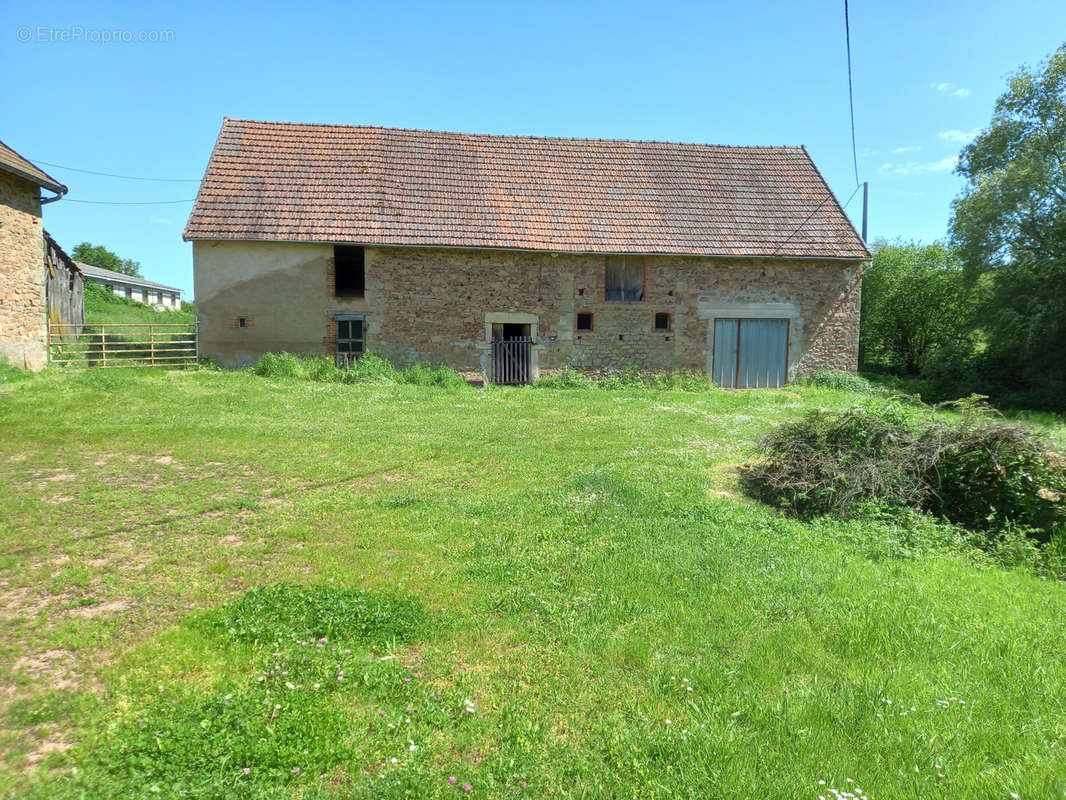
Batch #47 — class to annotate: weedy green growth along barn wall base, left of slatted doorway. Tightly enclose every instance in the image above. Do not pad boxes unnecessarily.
[251,352,468,388]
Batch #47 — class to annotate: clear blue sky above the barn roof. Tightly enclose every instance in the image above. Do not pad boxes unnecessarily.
[6,0,1066,297]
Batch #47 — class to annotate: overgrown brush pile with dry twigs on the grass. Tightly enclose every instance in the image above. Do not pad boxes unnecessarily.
[744,407,1066,541]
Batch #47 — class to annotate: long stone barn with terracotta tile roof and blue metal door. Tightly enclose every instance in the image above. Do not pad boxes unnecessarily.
[184,118,870,386]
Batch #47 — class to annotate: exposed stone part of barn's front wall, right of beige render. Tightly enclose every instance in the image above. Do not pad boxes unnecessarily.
[367,249,861,377]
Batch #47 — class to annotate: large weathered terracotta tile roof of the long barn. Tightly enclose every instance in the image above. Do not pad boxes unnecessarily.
[184,117,869,258]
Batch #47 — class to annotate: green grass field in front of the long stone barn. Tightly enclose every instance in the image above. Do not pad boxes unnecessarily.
[0,370,1066,800]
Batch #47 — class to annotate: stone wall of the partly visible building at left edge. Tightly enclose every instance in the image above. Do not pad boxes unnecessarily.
[0,172,47,369]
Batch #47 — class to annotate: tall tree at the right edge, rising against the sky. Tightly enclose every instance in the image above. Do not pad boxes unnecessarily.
[951,45,1066,388]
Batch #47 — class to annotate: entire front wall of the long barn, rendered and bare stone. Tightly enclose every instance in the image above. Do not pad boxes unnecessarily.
[193,242,861,377]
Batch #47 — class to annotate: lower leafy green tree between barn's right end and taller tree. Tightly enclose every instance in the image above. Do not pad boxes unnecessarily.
[859,241,972,375]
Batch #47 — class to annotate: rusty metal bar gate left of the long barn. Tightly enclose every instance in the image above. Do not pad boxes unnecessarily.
[48,322,196,368]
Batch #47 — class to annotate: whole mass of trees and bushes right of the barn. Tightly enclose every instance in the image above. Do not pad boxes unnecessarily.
[860,45,1066,410]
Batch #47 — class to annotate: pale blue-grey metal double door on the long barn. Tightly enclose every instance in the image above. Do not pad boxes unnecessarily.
[714,319,789,389]
